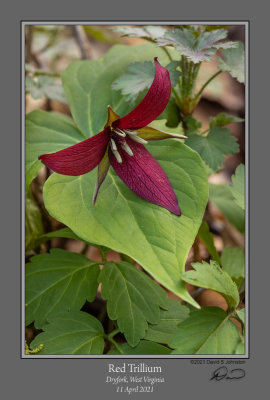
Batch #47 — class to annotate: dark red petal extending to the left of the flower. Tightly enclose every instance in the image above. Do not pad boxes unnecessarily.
[39,130,109,176]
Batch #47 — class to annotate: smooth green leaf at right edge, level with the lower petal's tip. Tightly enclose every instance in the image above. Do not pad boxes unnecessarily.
[209,183,245,233]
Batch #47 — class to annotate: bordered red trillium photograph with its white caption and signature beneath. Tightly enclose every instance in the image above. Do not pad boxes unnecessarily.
[21,20,249,366]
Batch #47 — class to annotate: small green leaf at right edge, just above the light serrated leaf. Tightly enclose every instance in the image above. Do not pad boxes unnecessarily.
[221,246,245,287]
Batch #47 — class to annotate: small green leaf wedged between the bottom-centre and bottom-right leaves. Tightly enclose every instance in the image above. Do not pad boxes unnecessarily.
[144,299,189,344]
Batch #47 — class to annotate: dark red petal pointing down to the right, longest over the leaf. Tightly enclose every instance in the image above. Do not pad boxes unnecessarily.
[109,140,181,215]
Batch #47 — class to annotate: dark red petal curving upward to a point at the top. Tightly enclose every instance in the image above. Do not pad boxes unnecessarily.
[115,57,171,129]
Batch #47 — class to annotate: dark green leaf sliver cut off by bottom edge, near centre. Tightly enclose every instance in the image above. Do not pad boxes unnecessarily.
[108,340,172,354]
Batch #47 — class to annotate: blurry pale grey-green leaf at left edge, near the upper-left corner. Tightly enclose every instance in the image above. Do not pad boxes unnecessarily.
[25,75,67,104]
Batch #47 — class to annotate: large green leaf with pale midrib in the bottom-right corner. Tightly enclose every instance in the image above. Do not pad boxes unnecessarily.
[170,307,239,355]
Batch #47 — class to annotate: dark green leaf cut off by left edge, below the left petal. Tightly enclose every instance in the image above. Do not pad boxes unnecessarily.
[25,192,44,252]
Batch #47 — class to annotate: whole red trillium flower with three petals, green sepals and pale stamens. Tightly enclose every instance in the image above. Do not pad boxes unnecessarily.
[39,57,185,215]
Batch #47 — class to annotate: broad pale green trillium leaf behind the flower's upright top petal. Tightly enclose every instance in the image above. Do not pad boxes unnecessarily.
[62,43,179,137]
